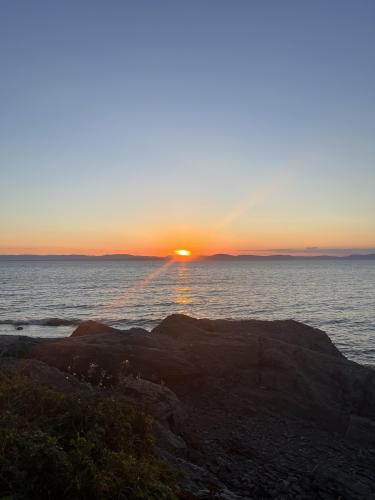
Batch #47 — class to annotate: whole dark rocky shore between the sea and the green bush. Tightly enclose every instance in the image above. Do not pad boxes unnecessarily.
[0,315,375,500]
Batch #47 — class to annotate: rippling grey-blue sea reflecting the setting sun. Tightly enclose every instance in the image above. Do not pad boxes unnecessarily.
[0,260,375,364]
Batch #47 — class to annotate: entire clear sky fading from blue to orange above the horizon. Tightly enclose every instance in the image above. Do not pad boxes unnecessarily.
[0,0,375,255]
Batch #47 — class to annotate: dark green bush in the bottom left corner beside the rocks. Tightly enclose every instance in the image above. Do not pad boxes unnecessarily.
[0,375,175,500]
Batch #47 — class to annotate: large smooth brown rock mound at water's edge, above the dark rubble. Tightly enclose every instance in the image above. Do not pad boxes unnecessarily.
[0,315,375,434]
